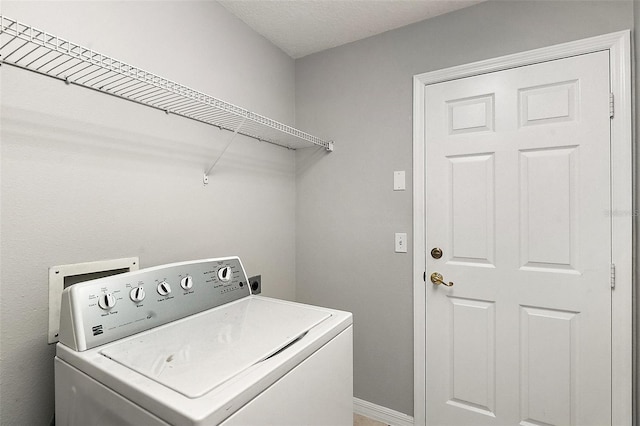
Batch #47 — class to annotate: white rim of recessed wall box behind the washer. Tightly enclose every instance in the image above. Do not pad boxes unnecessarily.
[48,257,140,343]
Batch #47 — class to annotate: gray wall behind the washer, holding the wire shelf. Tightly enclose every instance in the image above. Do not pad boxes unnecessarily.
[0,1,295,425]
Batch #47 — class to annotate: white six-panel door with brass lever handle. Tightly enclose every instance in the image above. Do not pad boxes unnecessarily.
[425,51,611,426]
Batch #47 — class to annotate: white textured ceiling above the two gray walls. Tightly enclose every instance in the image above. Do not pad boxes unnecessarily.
[219,0,483,58]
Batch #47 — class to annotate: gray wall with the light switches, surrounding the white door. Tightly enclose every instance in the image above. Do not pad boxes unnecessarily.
[296,1,634,415]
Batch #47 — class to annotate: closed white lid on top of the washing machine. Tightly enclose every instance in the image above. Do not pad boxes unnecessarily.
[100,298,331,398]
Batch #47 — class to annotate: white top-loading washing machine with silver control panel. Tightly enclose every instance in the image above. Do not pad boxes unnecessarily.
[54,257,353,426]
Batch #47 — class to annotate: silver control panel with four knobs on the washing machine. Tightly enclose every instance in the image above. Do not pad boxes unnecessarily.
[60,257,251,351]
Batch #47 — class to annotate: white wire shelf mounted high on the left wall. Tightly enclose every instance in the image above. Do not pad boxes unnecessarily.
[0,15,333,151]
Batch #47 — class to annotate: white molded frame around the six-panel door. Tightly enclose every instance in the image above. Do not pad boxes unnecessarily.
[413,31,635,425]
